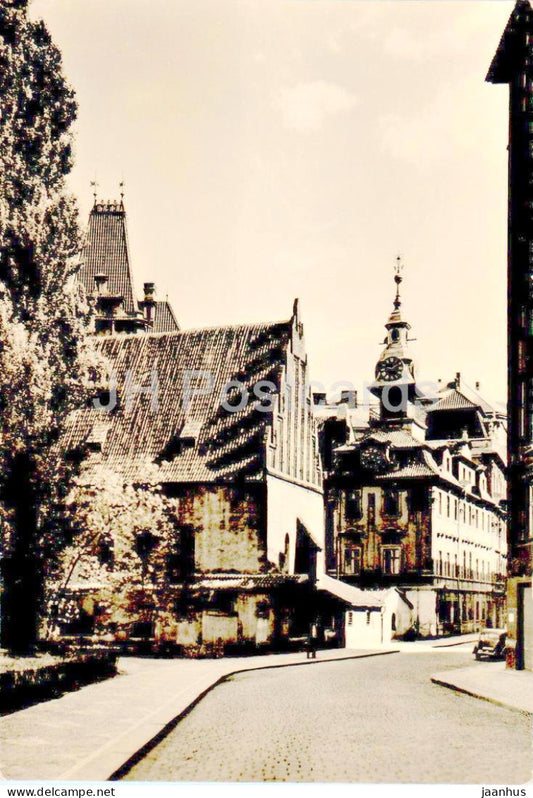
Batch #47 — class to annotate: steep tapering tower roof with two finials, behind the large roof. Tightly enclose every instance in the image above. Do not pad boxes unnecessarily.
[79,202,138,313]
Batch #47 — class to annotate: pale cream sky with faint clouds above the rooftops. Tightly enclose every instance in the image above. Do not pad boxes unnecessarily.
[31,0,514,410]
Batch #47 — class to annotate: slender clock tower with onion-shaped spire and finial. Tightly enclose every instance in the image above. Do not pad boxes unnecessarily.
[369,257,424,428]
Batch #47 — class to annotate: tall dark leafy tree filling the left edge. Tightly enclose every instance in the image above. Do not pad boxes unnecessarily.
[0,0,103,652]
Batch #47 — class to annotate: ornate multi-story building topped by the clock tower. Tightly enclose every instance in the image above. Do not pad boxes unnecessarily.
[316,273,507,635]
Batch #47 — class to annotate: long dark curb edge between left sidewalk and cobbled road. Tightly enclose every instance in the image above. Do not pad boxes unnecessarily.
[107,649,400,781]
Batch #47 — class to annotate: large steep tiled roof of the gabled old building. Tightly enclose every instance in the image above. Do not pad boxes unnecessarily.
[62,322,291,482]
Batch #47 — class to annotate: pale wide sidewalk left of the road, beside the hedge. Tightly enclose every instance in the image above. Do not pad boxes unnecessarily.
[0,647,398,781]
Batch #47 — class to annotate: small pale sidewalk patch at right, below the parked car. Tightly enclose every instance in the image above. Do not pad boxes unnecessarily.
[431,662,533,714]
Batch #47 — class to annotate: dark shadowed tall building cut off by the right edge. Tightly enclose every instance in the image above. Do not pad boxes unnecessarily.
[487,0,533,669]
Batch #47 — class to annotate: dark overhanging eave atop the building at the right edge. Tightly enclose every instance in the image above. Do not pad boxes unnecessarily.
[486,0,533,83]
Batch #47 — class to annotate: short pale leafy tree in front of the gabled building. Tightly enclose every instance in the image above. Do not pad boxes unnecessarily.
[45,463,180,639]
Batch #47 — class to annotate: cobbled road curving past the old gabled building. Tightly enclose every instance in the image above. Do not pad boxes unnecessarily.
[125,647,532,785]
